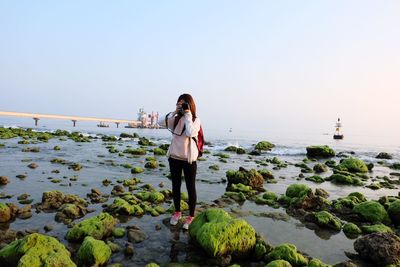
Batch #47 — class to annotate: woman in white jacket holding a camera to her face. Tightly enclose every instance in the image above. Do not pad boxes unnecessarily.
[159,94,200,230]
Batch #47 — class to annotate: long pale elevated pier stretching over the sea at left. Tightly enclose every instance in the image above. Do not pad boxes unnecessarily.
[0,111,141,128]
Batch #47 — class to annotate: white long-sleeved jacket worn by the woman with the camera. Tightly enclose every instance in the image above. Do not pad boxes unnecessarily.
[158,111,200,164]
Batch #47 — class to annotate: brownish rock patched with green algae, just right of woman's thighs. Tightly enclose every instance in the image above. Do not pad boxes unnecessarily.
[226,167,264,189]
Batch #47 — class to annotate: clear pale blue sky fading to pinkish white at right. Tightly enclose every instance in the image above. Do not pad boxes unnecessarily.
[0,0,400,136]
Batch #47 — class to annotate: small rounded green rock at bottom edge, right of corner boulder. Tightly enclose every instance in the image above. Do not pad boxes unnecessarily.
[76,236,112,266]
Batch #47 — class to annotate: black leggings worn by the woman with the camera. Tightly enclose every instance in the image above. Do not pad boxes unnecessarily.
[168,158,197,216]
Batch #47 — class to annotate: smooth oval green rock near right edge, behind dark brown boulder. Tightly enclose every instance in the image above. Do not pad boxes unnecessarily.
[353,201,390,223]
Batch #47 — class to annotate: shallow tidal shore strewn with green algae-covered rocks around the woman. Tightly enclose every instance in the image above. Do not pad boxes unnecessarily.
[0,128,400,267]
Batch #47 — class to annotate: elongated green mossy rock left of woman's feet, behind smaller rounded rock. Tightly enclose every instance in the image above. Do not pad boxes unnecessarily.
[66,212,117,241]
